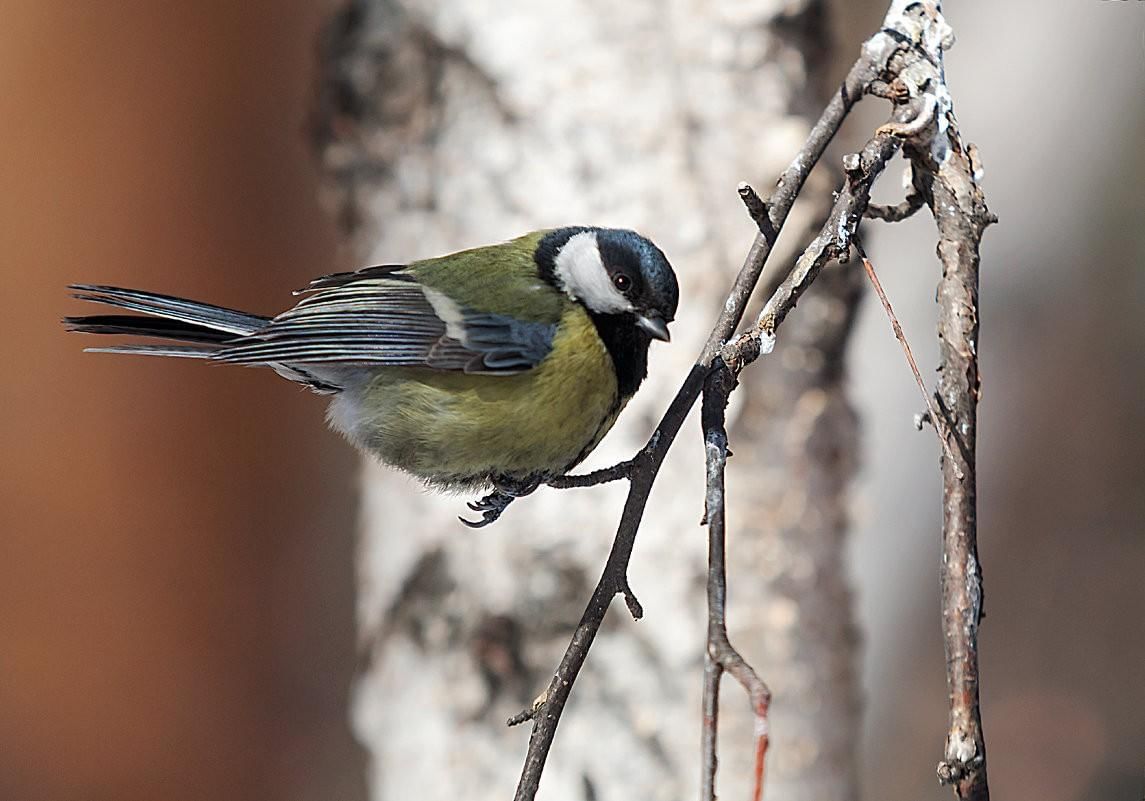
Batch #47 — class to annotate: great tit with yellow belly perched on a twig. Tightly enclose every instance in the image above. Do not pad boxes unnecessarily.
[64,227,679,525]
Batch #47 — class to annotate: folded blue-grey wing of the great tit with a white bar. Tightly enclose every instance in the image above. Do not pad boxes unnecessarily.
[212,275,556,374]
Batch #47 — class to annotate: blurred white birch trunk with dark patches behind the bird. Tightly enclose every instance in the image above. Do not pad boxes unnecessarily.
[316,0,856,800]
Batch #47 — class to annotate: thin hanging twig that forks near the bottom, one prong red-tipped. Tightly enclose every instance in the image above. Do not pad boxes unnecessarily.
[700,359,772,801]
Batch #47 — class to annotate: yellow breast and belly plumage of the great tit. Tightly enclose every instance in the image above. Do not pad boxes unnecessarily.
[331,306,619,486]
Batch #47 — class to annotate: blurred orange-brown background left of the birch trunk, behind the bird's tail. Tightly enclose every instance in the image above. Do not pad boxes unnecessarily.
[0,0,364,801]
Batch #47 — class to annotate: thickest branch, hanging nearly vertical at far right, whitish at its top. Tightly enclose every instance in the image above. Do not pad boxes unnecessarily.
[865,0,996,801]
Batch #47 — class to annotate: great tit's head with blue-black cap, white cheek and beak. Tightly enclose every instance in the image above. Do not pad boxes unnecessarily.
[536,228,680,342]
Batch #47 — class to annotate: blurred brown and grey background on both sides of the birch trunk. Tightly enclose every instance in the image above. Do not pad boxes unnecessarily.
[0,0,1145,801]
